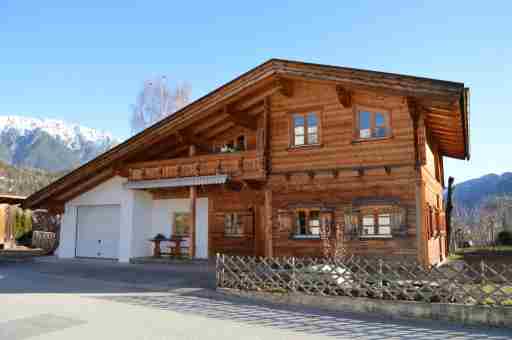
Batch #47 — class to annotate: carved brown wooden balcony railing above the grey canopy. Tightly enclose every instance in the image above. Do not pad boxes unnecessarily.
[129,150,265,181]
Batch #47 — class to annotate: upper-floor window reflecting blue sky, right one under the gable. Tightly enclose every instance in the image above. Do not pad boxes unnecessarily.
[356,108,391,139]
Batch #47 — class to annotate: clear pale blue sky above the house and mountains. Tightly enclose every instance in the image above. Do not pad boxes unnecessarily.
[0,0,512,181]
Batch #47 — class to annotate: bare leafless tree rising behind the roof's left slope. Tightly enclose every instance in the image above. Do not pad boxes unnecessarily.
[131,76,191,134]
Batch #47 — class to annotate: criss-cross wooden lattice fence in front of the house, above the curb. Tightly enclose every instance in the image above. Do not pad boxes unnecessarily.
[216,254,512,308]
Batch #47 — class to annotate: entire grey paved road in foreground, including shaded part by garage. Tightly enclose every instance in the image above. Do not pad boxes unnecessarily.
[0,262,512,340]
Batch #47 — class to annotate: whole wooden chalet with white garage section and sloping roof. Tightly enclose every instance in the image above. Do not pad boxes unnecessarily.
[25,59,469,264]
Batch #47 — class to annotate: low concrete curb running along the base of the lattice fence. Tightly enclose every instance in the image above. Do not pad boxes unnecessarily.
[217,288,512,328]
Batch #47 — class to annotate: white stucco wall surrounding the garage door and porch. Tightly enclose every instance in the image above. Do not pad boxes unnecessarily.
[57,177,208,262]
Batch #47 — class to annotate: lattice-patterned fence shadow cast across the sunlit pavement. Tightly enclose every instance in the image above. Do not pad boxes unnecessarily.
[98,290,512,340]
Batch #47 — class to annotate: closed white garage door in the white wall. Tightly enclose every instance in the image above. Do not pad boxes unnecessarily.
[76,205,121,259]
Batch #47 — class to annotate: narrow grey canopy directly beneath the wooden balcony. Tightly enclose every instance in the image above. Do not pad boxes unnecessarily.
[124,175,228,189]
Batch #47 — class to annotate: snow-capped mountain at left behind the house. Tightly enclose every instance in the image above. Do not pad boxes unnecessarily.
[0,116,119,172]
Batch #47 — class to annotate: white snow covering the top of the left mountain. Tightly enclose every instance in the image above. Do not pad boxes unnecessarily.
[0,116,118,150]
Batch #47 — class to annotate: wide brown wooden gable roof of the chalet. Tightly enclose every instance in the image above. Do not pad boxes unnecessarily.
[24,59,469,208]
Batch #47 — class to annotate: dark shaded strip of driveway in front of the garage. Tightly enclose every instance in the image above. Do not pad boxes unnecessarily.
[0,257,215,293]
